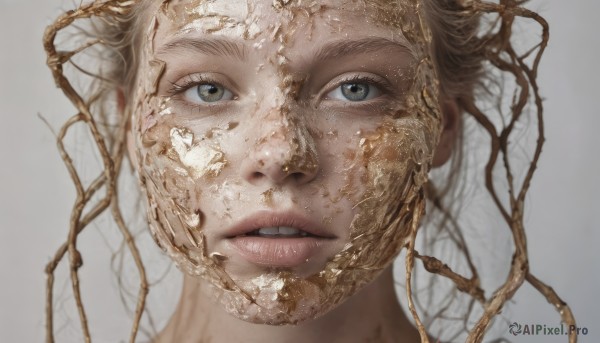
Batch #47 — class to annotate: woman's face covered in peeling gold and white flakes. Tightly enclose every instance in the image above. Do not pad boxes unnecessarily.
[133,0,440,324]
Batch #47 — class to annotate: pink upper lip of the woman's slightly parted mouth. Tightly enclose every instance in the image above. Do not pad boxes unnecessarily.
[225,211,336,238]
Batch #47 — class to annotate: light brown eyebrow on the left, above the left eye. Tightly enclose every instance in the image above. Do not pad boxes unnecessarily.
[157,37,247,61]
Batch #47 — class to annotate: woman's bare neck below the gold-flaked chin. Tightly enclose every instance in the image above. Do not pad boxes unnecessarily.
[156,266,420,343]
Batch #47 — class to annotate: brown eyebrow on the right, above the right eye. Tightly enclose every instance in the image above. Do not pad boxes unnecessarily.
[315,37,413,60]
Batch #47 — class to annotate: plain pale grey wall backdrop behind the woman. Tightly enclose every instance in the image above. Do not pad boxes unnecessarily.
[0,0,600,342]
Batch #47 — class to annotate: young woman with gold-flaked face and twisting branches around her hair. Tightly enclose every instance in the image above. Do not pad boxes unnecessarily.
[45,0,572,342]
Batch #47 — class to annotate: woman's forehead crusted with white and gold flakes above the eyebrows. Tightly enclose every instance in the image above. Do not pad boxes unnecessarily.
[151,0,417,44]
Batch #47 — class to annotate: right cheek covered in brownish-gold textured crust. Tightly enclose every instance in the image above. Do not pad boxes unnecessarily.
[340,119,431,267]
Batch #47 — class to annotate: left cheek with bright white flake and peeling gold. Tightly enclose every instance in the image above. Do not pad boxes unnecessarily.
[136,106,234,254]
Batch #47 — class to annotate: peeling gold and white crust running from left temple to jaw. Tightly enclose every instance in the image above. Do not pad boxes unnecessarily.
[134,7,253,298]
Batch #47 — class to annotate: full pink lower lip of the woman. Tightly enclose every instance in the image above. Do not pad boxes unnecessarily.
[230,236,327,267]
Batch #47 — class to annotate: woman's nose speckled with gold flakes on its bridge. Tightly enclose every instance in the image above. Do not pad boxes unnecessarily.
[241,123,319,185]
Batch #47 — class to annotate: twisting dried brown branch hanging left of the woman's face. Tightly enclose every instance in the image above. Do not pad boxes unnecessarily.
[43,1,142,343]
